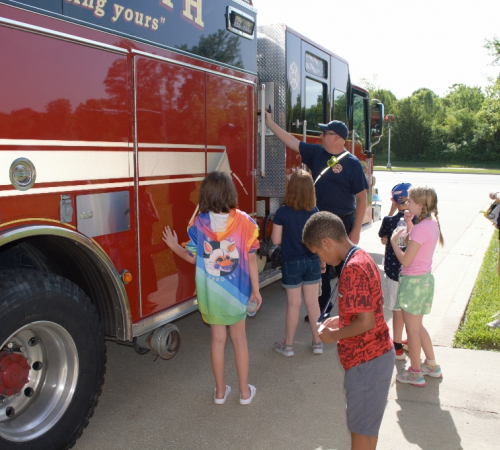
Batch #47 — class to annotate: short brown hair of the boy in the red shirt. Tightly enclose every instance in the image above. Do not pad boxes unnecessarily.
[302,211,347,248]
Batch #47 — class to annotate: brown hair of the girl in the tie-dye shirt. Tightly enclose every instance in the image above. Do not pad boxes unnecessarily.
[199,170,238,213]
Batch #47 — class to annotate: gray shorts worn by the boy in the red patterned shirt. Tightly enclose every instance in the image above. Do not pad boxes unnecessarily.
[344,348,396,436]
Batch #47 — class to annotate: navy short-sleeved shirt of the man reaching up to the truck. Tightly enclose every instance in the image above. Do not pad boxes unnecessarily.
[299,142,368,216]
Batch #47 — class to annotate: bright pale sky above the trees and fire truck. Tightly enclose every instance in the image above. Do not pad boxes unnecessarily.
[253,0,500,98]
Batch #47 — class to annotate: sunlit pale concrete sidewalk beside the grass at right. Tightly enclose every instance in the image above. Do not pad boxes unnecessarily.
[379,208,500,450]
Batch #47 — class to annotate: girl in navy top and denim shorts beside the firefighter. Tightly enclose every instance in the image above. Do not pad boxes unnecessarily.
[271,169,326,356]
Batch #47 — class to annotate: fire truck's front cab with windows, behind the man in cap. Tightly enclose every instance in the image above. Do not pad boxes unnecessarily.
[257,24,384,266]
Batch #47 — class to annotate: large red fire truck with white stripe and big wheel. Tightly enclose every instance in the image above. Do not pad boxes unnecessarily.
[0,0,383,449]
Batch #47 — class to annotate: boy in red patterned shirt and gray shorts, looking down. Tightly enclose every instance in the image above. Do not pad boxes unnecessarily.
[302,211,395,450]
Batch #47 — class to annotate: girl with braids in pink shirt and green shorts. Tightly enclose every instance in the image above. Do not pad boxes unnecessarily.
[391,186,444,386]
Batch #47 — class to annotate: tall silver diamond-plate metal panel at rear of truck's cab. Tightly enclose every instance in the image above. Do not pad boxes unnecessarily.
[257,25,286,197]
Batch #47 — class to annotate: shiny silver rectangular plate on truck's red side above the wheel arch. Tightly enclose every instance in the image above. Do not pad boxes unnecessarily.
[76,191,130,237]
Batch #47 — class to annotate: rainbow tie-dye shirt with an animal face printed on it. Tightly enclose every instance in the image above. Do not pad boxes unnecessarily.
[185,209,259,325]
